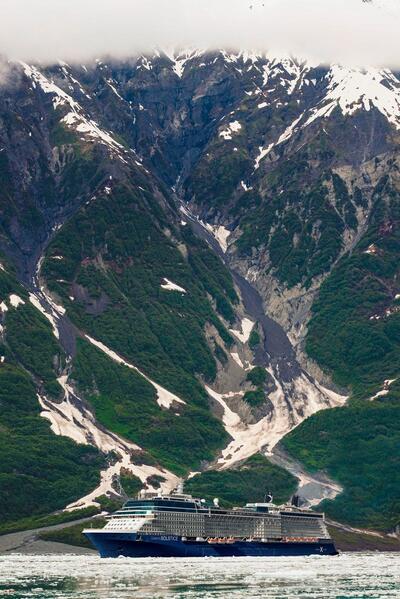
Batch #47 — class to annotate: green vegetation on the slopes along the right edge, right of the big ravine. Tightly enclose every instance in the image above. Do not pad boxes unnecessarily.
[283,178,400,530]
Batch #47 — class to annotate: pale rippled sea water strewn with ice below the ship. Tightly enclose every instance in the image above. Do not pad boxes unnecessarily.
[0,553,400,599]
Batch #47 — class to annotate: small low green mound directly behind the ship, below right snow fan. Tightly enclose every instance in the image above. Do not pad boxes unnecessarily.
[185,454,297,506]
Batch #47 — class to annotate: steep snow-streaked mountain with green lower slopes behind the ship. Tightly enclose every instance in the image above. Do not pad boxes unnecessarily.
[0,50,400,532]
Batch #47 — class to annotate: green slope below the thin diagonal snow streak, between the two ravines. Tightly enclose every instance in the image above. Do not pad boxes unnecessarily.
[74,340,227,474]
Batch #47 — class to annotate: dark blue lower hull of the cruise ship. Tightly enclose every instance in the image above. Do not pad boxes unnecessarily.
[85,531,337,557]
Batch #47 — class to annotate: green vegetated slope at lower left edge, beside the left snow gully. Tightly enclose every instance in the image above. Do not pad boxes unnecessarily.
[0,364,103,523]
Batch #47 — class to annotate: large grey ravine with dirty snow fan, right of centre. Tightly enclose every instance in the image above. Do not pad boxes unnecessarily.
[182,203,347,505]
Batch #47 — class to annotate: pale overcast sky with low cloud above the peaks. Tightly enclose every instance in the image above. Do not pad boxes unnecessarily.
[0,0,400,67]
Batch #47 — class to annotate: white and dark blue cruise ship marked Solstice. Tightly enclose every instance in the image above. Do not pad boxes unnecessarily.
[83,489,337,558]
